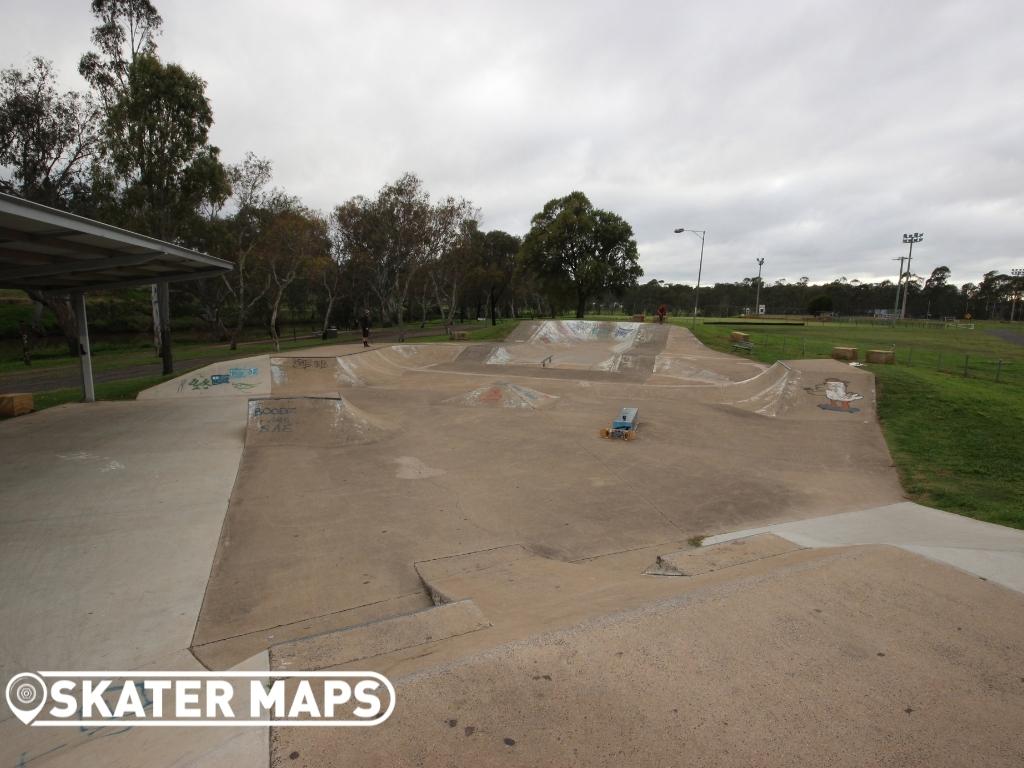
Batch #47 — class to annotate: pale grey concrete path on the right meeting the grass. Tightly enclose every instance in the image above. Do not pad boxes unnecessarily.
[705,502,1024,592]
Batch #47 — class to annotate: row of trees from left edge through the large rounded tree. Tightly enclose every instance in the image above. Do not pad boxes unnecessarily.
[0,0,642,353]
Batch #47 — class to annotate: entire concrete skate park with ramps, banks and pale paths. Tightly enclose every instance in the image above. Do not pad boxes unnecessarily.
[6,321,1024,766]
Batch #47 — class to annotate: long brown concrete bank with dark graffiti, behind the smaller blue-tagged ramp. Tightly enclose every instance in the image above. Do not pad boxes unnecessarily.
[270,344,464,395]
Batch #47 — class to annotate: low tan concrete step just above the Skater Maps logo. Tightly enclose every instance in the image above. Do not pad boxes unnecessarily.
[270,600,490,671]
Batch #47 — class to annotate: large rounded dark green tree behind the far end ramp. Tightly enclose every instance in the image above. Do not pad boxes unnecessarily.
[521,191,643,317]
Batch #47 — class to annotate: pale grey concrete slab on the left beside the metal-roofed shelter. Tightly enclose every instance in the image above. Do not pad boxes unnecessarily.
[0,400,267,768]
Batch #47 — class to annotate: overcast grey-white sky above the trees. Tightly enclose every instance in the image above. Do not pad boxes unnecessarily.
[0,0,1024,284]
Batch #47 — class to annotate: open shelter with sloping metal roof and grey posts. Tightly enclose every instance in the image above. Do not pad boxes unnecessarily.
[0,194,232,402]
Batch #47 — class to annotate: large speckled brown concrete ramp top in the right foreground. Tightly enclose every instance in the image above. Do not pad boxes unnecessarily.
[280,547,1024,768]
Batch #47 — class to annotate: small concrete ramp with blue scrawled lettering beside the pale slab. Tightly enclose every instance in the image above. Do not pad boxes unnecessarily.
[246,397,389,450]
